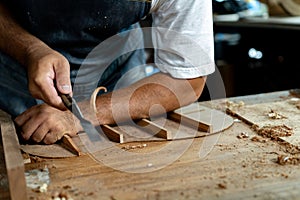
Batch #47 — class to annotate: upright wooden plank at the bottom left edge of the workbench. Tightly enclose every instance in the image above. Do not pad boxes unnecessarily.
[0,115,27,200]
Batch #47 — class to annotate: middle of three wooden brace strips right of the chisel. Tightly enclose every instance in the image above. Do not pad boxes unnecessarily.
[137,119,172,140]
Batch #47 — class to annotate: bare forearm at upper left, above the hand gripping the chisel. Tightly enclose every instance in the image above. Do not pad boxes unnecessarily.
[0,3,47,65]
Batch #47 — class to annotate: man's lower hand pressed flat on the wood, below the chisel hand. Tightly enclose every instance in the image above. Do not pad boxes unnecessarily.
[15,104,82,144]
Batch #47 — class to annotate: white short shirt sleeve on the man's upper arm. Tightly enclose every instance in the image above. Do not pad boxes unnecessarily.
[150,0,215,78]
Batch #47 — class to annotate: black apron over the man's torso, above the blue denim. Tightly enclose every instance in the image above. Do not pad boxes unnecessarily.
[0,0,151,59]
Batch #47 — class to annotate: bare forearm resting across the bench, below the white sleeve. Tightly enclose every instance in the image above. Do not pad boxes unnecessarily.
[82,73,206,125]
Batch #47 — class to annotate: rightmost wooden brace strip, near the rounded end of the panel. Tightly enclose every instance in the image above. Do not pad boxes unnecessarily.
[168,112,213,133]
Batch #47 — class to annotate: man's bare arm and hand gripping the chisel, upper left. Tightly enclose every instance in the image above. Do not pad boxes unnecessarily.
[0,3,71,109]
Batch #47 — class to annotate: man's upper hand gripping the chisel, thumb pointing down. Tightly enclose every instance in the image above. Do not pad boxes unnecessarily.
[26,45,72,110]
